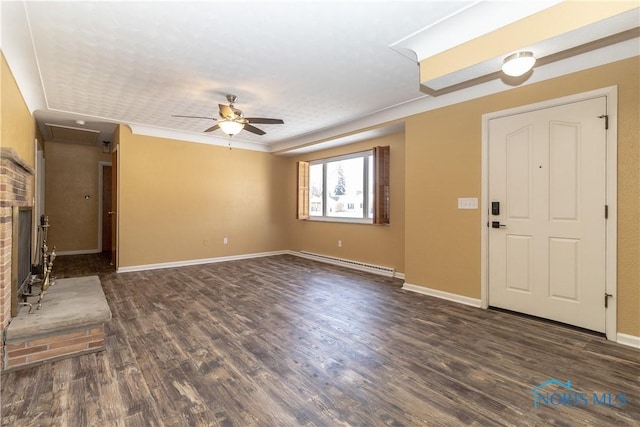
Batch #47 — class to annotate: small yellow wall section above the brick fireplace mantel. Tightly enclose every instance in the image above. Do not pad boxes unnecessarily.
[0,55,36,168]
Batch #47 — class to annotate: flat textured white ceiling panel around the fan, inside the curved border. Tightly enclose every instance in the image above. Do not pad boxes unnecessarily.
[21,1,469,150]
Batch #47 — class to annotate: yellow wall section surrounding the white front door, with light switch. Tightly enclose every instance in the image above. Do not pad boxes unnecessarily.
[405,57,640,336]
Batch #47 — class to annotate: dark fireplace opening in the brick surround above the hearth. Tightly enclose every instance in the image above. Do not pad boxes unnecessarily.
[11,206,33,317]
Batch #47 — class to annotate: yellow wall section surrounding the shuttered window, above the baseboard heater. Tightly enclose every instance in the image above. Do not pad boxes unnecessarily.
[286,133,405,272]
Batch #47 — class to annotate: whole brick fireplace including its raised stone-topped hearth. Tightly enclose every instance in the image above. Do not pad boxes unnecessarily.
[0,148,111,371]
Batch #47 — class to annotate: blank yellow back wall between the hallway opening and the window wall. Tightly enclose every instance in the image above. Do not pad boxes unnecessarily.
[117,126,288,267]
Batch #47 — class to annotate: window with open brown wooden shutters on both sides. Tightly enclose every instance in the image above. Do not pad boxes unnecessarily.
[298,147,389,224]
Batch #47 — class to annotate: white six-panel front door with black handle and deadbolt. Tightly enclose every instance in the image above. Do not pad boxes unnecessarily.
[488,96,607,332]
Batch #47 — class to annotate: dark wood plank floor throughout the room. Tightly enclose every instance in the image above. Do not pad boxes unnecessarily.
[2,255,640,427]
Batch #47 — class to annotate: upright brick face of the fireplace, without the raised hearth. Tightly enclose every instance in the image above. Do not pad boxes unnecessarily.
[0,147,34,368]
